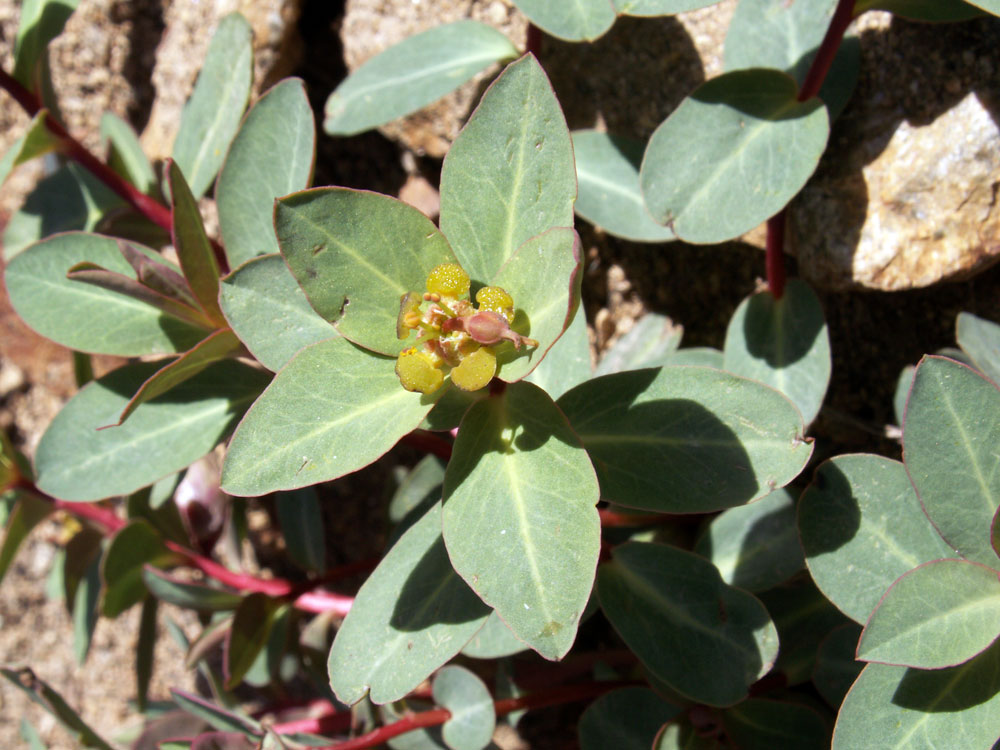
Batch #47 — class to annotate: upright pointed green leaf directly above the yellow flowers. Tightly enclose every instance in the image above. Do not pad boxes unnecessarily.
[440,55,576,286]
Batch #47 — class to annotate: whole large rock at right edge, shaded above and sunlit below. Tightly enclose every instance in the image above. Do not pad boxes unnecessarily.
[789,13,1000,291]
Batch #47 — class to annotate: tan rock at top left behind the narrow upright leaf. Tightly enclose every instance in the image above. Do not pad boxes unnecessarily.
[142,0,302,159]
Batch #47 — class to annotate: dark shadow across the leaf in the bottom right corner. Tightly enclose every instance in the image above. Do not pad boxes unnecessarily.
[892,641,1000,713]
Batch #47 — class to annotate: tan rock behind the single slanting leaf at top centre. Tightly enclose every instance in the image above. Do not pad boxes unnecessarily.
[340,0,528,158]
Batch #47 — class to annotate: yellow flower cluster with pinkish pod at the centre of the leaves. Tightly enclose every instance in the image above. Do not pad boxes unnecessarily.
[396,263,538,393]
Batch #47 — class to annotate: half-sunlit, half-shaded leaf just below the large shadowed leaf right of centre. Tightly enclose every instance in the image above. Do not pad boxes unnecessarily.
[694,490,805,591]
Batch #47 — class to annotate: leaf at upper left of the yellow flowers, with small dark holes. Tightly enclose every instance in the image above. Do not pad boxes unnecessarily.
[274,188,455,356]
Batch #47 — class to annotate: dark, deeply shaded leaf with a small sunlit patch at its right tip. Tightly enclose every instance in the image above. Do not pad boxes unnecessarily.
[597,542,778,706]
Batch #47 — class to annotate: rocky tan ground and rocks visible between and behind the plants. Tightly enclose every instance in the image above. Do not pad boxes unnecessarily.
[0,0,1000,748]
